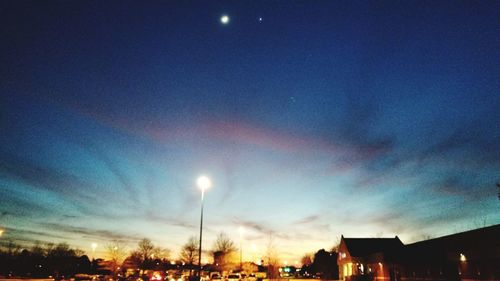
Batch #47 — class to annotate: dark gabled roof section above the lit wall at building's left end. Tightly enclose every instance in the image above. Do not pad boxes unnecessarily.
[342,236,404,257]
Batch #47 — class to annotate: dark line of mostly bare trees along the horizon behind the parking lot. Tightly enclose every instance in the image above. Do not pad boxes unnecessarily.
[0,233,338,279]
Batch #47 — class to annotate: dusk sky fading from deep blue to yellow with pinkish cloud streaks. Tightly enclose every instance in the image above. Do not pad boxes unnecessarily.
[0,0,500,260]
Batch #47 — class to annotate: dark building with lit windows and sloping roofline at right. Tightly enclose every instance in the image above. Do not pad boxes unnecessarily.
[337,225,500,281]
